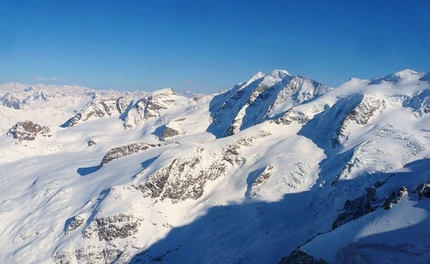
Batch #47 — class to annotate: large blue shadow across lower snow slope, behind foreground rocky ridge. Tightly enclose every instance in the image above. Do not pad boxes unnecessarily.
[130,159,430,264]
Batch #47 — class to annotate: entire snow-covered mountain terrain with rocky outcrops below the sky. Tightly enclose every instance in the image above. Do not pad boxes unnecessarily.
[0,70,430,264]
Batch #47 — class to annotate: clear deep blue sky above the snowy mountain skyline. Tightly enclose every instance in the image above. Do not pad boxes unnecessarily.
[0,0,430,93]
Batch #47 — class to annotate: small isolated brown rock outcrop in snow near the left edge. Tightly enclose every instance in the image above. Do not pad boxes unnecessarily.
[8,120,51,141]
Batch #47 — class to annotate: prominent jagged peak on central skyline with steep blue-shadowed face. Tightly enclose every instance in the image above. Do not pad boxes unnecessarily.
[208,70,331,137]
